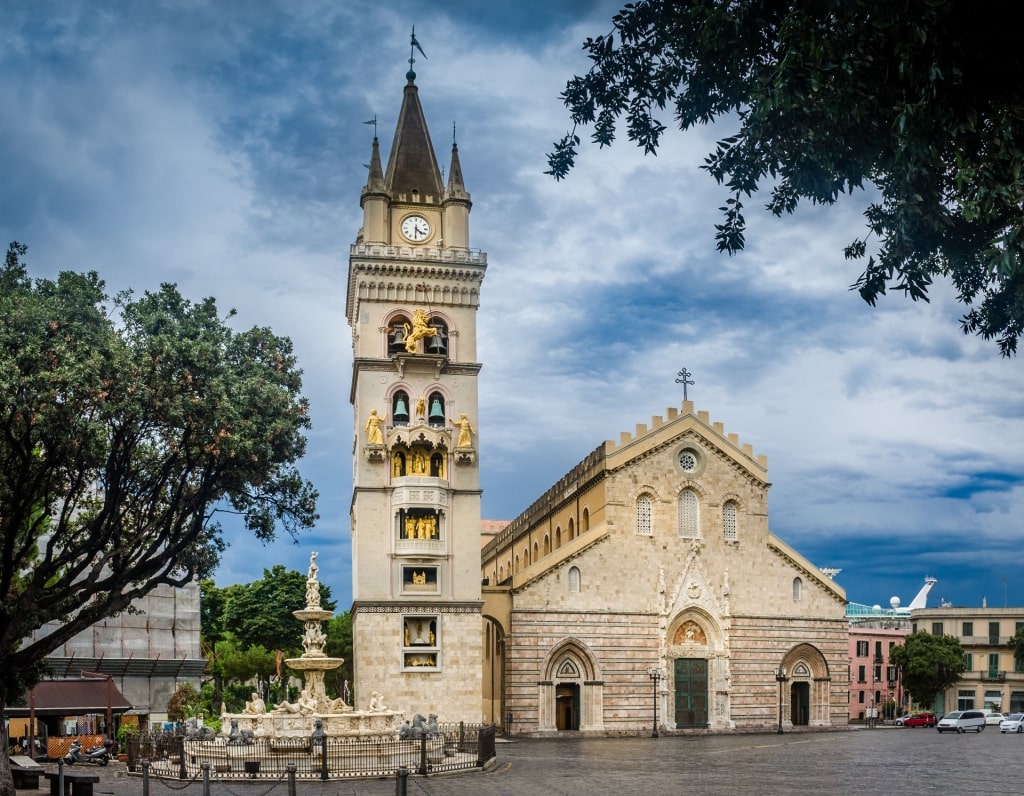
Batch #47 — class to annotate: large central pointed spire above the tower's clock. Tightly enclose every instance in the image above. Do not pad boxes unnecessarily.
[384,77,442,203]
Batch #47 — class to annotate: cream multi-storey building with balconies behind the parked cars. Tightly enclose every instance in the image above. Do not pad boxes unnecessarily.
[910,606,1024,713]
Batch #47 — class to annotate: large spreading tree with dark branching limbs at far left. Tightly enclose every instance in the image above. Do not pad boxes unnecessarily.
[0,243,316,796]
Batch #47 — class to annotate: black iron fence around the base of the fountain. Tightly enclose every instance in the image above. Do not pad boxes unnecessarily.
[128,722,495,780]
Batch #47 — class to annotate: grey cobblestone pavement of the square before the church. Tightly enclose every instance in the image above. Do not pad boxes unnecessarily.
[28,727,1024,796]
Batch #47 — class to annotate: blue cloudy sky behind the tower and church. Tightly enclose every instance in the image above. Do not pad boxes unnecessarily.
[8,0,1024,608]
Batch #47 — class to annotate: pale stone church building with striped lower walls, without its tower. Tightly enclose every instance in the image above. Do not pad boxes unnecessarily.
[481,402,849,734]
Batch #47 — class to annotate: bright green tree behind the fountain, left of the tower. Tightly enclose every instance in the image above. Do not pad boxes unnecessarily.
[222,563,335,655]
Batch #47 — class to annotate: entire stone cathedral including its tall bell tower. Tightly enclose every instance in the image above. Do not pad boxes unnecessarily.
[346,61,849,735]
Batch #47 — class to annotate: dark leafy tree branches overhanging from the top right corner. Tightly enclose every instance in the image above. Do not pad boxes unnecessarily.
[548,0,1024,357]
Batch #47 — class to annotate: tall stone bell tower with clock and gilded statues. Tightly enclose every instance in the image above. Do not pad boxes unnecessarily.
[346,54,486,721]
